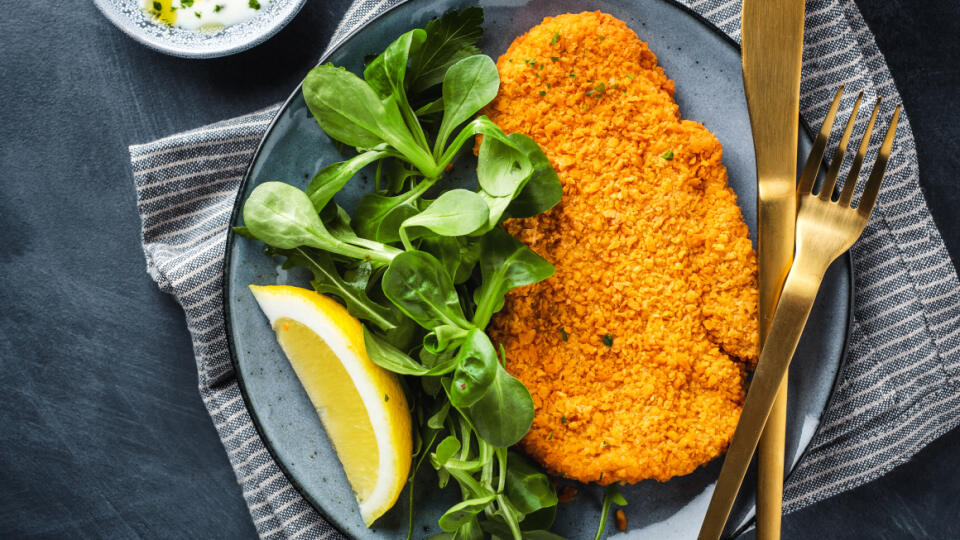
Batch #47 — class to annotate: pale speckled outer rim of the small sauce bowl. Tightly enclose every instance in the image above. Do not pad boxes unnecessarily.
[93,0,307,58]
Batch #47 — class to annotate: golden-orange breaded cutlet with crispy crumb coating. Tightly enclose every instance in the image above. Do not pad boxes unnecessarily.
[485,12,758,484]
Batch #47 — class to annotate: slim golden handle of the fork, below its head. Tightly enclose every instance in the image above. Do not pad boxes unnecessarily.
[698,252,826,540]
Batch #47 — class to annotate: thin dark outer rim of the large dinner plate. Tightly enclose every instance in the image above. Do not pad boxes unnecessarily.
[221,0,856,538]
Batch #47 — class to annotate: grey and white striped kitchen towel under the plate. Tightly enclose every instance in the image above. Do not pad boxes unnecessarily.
[130,0,960,538]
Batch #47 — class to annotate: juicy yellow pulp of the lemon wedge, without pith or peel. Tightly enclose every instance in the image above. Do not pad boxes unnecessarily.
[273,318,380,502]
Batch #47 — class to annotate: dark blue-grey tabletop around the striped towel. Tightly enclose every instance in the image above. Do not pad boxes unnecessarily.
[0,0,960,538]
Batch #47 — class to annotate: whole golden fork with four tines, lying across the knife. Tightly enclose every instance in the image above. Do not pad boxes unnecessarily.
[699,87,900,540]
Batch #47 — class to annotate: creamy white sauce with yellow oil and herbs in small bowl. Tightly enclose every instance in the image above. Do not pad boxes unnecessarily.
[144,0,271,32]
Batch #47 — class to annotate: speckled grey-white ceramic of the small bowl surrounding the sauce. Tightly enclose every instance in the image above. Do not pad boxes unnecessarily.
[94,0,307,58]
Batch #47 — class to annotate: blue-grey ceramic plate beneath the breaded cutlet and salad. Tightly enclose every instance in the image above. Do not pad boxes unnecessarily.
[224,0,852,539]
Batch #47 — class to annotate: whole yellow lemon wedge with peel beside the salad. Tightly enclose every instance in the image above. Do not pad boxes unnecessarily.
[250,285,413,527]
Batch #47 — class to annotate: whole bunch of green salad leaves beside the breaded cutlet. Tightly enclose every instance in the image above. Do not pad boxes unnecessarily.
[234,7,576,540]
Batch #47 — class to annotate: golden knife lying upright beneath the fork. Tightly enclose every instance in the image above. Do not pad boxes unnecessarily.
[712,0,804,540]
